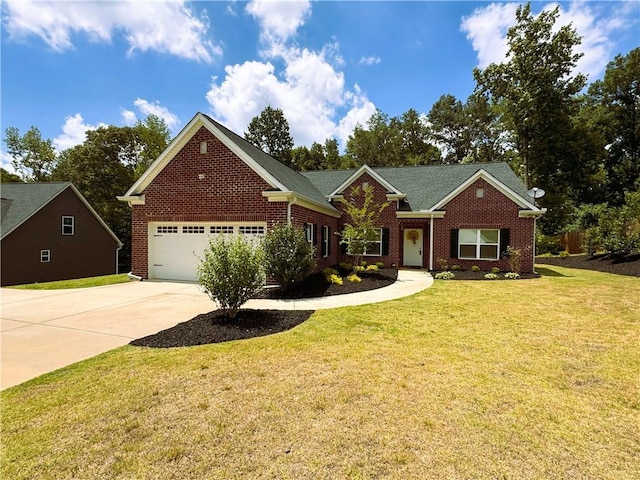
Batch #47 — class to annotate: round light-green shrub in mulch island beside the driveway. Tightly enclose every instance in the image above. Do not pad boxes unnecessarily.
[197,234,264,319]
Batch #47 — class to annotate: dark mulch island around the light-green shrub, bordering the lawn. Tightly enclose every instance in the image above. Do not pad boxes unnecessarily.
[130,309,313,348]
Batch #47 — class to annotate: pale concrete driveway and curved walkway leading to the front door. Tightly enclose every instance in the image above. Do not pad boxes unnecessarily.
[0,270,433,389]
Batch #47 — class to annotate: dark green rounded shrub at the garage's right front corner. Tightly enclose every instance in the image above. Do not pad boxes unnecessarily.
[262,223,316,290]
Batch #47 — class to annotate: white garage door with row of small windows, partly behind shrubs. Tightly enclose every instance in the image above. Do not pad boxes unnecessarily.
[149,223,266,281]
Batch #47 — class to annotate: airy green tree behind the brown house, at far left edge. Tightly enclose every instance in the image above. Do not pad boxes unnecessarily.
[4,126,56,182]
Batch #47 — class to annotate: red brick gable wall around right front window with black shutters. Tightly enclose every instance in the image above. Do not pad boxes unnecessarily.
[433,179,533,273]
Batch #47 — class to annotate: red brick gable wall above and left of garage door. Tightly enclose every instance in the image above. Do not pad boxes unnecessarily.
[131,127,287,278]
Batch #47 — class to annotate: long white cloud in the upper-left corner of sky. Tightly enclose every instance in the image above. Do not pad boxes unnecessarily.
[4,0,222,62]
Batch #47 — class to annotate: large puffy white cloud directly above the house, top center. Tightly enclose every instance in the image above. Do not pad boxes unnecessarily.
[207,1,375,146]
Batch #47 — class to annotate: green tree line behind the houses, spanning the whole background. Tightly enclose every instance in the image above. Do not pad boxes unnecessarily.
[1,4,640,261]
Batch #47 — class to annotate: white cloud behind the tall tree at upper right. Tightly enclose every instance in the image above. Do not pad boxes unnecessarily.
[461,1,638,78]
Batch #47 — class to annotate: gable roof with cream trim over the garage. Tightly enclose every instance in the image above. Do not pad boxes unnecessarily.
[121,113,337,212]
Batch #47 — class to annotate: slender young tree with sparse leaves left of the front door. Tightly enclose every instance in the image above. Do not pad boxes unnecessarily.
[339,185,389,266]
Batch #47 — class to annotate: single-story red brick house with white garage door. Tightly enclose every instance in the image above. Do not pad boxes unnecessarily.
[118,113,544,280]
